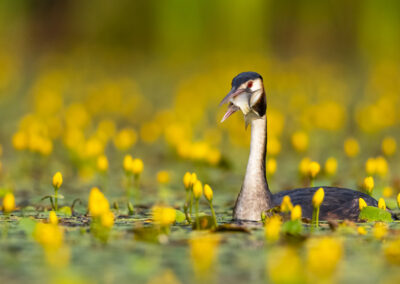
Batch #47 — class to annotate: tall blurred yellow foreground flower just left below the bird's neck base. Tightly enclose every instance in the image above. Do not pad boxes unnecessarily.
[189,234,220,277]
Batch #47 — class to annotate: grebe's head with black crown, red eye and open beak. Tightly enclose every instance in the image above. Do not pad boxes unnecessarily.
[220,72,267,127]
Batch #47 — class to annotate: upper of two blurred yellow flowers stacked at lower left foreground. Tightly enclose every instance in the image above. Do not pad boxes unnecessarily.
[33,223,64,250]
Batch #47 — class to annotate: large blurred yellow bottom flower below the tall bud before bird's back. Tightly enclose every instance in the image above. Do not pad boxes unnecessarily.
[306,237,343,282]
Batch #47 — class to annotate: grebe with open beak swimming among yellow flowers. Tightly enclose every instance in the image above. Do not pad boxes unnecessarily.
[220,72,397,221]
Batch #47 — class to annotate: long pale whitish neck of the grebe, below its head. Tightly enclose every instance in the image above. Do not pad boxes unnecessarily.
[234,115,272,221]
